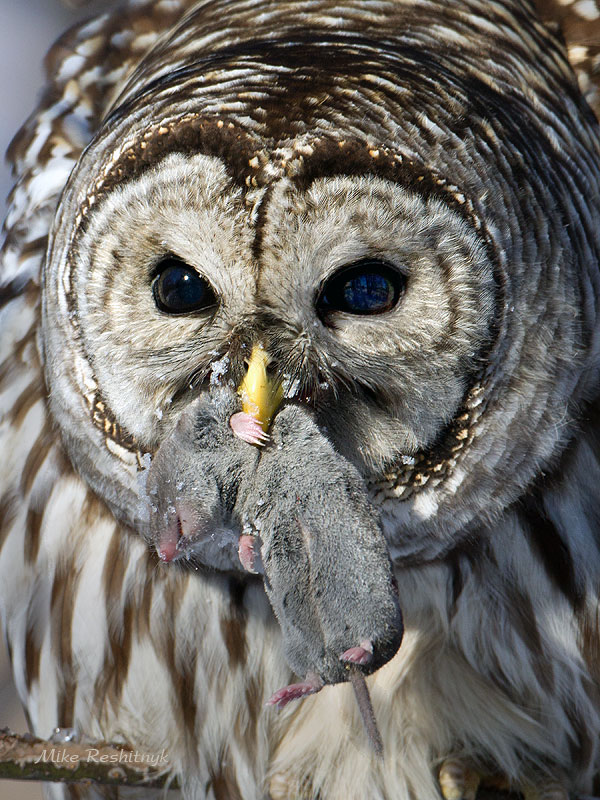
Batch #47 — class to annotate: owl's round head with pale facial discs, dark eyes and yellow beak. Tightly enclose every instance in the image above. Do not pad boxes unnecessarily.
[43,20,595,566]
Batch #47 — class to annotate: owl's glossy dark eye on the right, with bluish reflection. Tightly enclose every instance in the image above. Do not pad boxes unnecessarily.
[317,259,405,315]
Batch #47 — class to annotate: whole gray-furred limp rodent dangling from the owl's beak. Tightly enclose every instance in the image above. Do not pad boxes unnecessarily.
[147,387,403,750]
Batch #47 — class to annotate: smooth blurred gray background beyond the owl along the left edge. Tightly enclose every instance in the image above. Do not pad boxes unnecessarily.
[0,0,107,800]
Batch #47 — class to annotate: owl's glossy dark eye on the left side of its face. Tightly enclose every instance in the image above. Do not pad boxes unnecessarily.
[152,256,216,314]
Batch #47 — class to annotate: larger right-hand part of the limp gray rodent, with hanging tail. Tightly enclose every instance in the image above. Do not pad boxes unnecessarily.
[235,405,403,751]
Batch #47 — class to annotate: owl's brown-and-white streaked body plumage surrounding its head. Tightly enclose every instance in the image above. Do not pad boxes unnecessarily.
[0,0,600,800]
